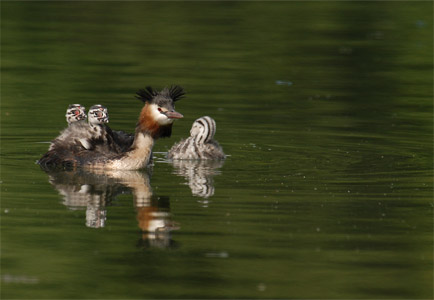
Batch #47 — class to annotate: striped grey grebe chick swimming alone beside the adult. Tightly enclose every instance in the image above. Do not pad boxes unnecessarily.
[167,116,226,159]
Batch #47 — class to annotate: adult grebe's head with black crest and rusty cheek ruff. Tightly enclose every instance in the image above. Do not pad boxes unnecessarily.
[136,85,185,138]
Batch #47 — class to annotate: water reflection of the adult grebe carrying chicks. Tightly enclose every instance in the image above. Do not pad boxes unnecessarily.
[43,169,179,248]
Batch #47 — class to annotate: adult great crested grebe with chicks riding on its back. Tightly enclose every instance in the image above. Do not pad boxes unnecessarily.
[38,86,185,170]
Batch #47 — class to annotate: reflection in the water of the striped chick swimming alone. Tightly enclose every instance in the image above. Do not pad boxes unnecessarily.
[171,160,224,206]
